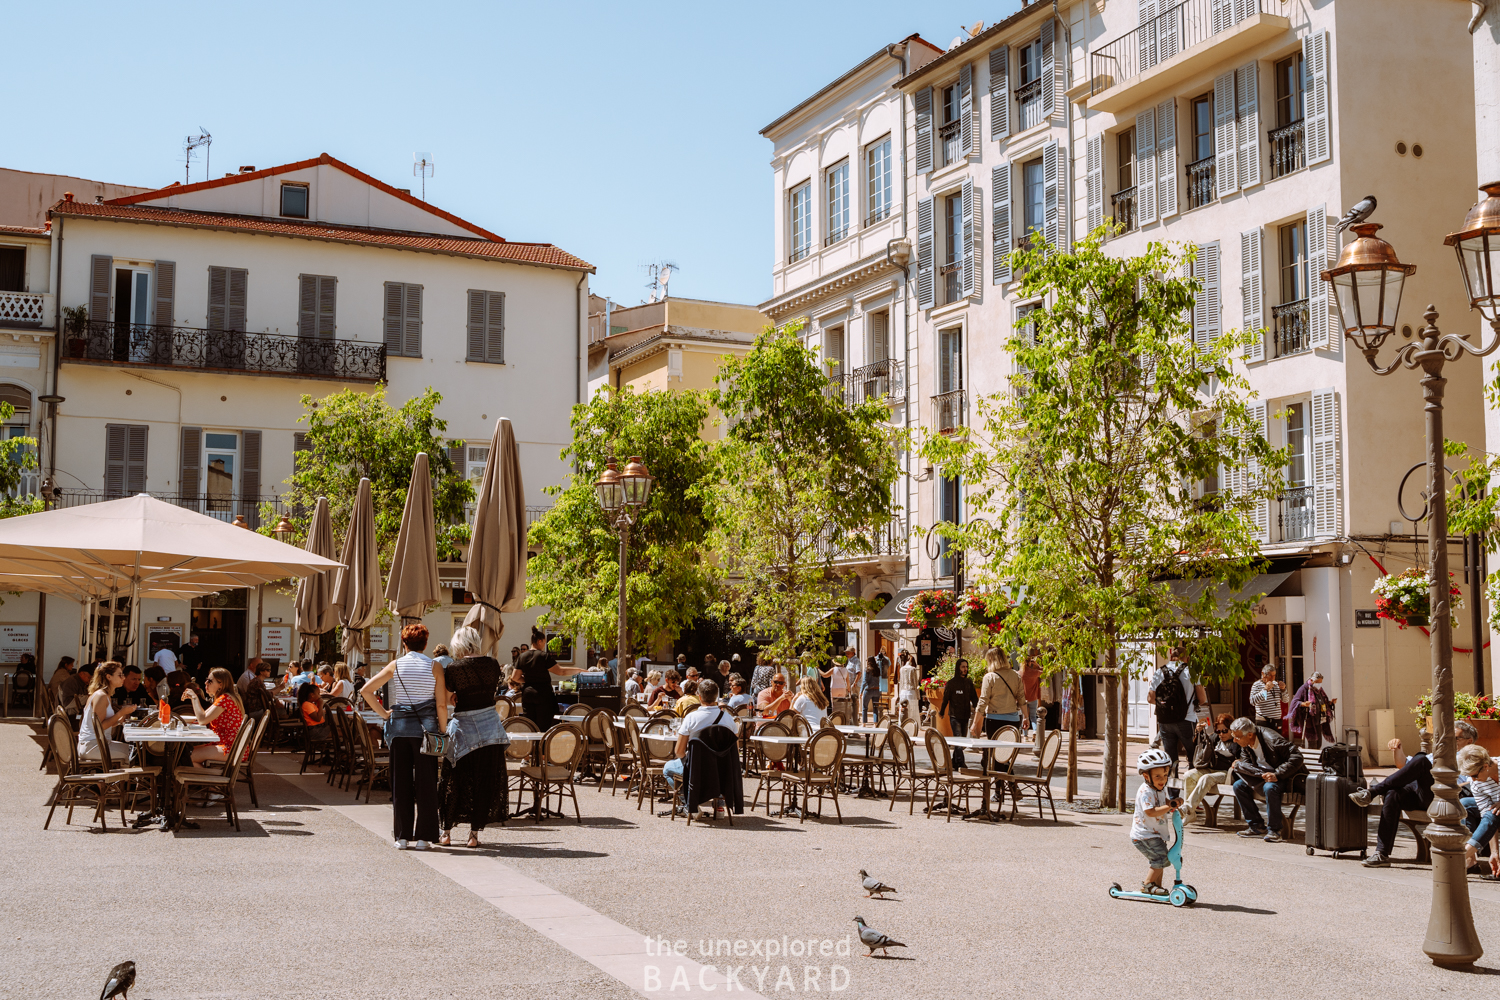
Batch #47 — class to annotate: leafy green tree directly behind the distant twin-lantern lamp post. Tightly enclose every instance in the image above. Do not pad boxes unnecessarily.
[527,387,716,651]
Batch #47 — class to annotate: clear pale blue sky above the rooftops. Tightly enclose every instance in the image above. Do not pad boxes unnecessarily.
[11,0,1019,304]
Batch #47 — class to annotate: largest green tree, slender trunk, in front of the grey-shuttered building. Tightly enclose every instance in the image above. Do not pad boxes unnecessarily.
[923,231,1286,808]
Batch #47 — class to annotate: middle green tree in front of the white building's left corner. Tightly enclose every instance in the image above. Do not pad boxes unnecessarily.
[704,325,899,668]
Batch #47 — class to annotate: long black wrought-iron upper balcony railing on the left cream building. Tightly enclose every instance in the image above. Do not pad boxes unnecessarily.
[63,321,386,382]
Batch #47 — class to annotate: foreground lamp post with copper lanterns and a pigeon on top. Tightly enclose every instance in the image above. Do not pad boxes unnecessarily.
[1322,183,1500,966]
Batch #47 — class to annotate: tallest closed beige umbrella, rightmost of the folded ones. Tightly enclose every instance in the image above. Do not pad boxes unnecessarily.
[464,417,527,654]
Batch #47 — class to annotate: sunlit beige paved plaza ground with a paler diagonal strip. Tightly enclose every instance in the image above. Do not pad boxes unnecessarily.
[0,724,1500,1000]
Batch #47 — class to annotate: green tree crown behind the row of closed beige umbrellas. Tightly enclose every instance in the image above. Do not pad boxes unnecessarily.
[268,385,474,565]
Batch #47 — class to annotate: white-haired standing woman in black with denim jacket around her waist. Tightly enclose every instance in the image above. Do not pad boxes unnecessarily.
[438,625,510,847]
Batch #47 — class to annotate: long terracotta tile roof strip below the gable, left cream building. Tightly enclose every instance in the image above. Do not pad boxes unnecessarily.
[48,197,594,271]
